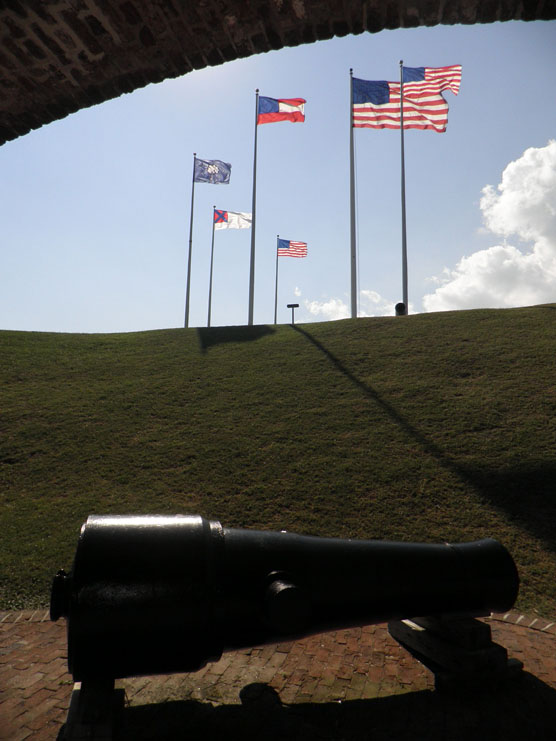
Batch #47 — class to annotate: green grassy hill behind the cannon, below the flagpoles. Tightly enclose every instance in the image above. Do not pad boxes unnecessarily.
[0,305,556,617]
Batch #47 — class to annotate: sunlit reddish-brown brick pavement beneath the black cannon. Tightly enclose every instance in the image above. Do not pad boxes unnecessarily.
[0,611,556,741]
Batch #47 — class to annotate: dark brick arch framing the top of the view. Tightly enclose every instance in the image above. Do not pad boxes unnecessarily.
[0,0,556,144]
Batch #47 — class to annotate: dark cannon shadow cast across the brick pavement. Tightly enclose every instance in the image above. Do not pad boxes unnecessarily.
[114,672,556,741]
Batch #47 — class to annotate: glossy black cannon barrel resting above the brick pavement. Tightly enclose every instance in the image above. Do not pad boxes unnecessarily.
[50,515,519,680]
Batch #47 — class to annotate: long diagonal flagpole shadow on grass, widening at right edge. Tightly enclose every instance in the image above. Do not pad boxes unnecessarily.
[293,325,556,551]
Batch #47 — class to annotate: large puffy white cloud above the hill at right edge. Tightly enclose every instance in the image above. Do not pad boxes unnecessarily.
[423,141,556,311]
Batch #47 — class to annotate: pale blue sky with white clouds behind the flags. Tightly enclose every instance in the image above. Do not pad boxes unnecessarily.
[0,22,556,332]
